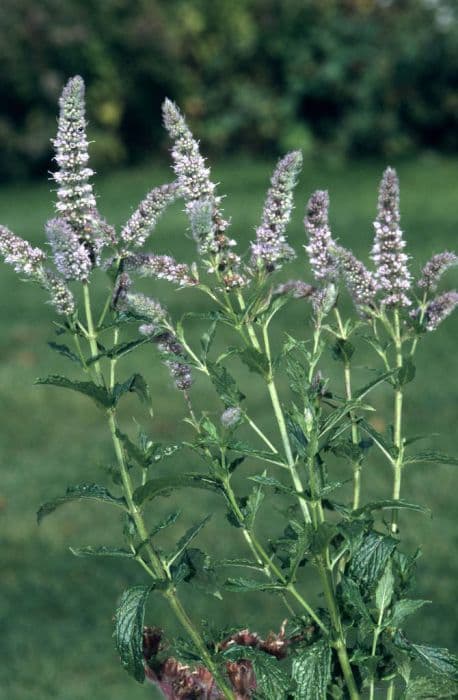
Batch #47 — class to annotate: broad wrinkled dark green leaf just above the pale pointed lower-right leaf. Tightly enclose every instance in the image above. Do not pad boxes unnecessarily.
[349,530,397,586]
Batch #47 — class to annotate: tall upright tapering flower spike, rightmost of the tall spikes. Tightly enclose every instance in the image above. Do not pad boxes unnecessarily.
[371,168,411,306]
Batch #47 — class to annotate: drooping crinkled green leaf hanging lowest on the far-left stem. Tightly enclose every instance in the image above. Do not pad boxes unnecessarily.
[115,586,151,683]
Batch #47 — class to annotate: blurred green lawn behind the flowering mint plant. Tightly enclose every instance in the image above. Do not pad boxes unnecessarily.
[0,156,458,700]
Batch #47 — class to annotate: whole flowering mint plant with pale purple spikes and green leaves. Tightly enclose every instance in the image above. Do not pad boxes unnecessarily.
[0,77,458,700]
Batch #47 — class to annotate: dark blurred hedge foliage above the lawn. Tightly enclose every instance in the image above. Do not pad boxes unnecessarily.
[0,0,458,180]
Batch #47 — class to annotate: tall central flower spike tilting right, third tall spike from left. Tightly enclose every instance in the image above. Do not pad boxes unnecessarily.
[251,151,302,272]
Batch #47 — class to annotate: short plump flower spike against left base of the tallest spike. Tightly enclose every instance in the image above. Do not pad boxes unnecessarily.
[46,219,92,282]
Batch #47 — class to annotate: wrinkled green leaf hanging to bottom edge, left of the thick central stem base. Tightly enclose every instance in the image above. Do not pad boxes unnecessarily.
[292,640,332,700]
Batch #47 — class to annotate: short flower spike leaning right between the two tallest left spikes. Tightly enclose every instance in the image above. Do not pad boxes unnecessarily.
[120,182,178,250]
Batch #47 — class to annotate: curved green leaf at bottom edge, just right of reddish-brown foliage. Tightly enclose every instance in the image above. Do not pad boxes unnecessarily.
[222,644,290,700]
